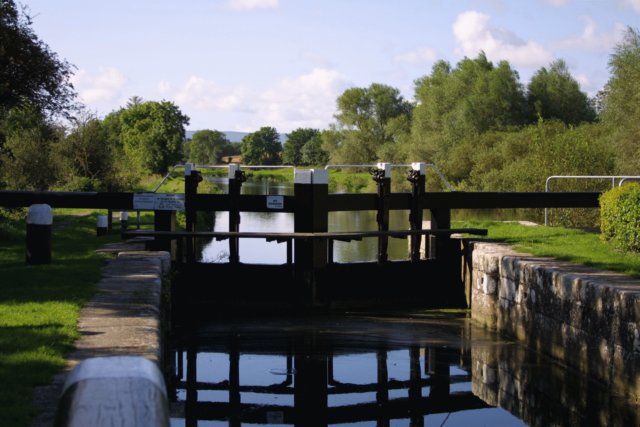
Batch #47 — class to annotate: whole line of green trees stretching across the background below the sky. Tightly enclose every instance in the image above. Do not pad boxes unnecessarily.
[0,0,640,197]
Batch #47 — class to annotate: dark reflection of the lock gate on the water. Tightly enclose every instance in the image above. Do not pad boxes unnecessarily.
[172,346,489,425]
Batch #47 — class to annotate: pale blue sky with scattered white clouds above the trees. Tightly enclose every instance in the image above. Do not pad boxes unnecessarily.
[21,0,640,133]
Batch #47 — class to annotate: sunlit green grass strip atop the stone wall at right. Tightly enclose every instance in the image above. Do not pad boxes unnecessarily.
[452,221,640,278]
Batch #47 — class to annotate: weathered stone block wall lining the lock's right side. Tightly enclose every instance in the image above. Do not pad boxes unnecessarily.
[467,242,640,403]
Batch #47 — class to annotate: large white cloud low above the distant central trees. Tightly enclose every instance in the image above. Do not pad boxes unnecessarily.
[255,68,349,132]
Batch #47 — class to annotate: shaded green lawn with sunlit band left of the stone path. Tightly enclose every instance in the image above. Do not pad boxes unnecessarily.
[0,209,119,426]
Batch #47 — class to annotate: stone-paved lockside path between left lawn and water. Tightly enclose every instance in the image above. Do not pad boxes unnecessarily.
[32,243,171,427]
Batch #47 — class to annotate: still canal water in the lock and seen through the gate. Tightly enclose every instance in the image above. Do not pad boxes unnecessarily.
[168,179,640,426]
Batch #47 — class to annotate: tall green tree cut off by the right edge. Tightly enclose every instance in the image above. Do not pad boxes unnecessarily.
[601,27,640,175]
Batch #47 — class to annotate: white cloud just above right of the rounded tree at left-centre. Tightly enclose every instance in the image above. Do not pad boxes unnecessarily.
[175,76,245,111]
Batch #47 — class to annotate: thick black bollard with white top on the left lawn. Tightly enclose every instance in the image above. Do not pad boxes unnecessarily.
[26,204,53,264]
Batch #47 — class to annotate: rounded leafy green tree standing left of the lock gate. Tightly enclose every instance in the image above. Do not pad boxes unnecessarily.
[116,101,189,174]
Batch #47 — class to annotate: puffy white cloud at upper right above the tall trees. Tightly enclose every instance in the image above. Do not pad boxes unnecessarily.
[453,11,553,67]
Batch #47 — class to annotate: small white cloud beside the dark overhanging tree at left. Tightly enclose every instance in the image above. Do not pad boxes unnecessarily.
[71,67,126,104]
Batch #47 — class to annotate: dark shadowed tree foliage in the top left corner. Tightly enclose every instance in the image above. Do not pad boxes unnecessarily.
[0,0,76,120]
